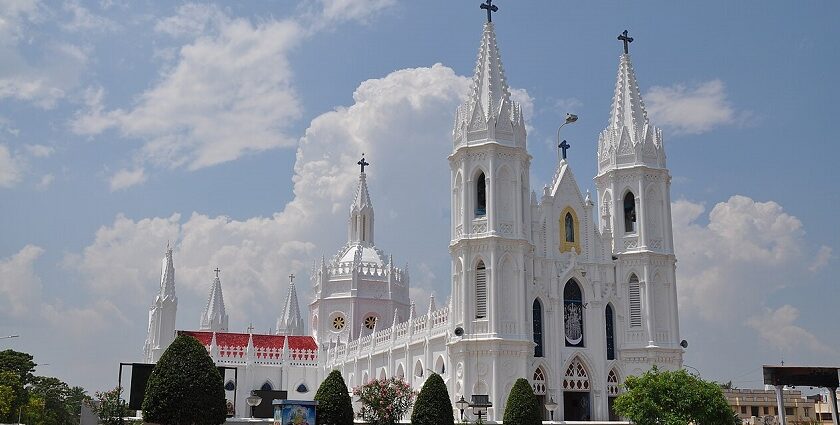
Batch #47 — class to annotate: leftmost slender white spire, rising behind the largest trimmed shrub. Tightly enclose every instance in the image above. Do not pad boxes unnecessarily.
[143,243,178,363]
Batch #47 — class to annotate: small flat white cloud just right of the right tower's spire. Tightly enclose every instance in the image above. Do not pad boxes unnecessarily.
[644,80,737,134]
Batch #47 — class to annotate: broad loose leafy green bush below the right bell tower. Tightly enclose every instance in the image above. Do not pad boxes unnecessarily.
[614,367,741,425]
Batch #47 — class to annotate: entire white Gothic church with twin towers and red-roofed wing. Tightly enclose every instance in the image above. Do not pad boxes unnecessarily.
[145,13,683,421]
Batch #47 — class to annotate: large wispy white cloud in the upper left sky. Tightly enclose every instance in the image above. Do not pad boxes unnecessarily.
[71,10,303,170]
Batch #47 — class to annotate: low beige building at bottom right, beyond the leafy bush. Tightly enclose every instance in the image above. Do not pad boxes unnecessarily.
[723,389,816,425]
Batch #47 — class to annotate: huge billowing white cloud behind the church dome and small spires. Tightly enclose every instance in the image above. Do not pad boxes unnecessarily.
[66,64,486,326]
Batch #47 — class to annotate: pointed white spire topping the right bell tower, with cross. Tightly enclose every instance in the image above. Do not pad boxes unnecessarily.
[598,31,665,174]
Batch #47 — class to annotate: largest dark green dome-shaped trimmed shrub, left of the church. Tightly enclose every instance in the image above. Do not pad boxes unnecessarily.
[143,335,227,425]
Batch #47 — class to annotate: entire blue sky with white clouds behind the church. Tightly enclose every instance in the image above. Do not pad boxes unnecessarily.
[0,0,840,390]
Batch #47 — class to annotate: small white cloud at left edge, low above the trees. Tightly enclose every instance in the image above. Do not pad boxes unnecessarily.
[0,245,44,318]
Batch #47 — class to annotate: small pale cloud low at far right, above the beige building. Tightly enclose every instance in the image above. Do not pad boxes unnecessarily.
[747,305,837,354]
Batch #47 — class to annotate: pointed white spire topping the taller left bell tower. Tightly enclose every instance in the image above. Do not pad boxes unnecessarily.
[453,19,525,148]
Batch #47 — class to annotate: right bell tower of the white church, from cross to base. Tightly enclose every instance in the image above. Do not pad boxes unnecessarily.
[595,31,682,362]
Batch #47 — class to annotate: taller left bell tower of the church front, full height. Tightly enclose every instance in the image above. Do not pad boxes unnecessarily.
[449,2,533,419]
